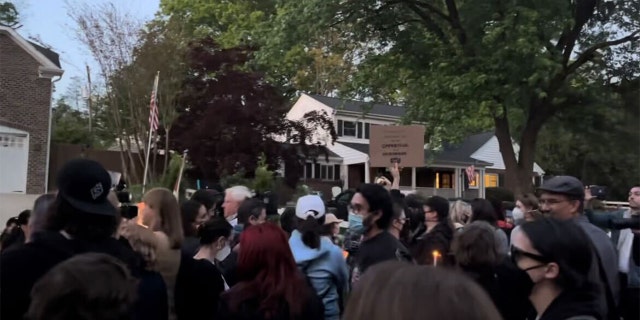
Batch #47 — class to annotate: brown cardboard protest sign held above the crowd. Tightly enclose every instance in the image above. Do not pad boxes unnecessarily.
[369,125,425,167]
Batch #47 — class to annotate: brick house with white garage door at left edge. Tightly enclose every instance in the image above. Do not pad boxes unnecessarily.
[0,26,63,194]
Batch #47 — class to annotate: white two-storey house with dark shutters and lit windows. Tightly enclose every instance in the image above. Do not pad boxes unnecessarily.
[287,94,544,198]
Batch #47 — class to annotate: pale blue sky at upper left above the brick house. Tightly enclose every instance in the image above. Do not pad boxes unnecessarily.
[12,0,160,99]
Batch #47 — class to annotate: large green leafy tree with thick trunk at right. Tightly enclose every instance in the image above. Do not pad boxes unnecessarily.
[262,0,640,192]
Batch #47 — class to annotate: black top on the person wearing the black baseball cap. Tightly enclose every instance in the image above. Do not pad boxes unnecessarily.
[0,232,166,320]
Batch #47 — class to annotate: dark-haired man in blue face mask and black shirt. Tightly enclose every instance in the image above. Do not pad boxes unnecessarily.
[349,183,413,283]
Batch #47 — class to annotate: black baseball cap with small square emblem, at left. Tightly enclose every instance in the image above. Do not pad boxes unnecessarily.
[57,159,116,216]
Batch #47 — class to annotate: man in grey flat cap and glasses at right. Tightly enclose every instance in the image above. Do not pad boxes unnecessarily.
[538,176,620,319]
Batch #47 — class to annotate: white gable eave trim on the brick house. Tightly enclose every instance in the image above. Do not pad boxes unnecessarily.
[0,25,64,78]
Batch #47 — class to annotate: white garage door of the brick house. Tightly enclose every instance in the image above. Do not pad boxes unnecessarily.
[0,126,29,194]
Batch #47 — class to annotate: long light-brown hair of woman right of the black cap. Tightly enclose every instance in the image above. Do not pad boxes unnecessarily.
[142,188,184,249]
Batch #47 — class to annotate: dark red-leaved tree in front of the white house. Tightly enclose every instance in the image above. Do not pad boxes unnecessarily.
[170,39,336,186]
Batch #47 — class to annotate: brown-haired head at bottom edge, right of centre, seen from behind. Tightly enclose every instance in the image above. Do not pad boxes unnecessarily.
[343,261,501,320]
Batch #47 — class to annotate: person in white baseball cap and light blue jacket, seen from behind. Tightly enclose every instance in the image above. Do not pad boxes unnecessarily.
[289,195,349,320]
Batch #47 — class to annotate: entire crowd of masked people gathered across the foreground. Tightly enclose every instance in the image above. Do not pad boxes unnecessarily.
[0,159,640,320]
